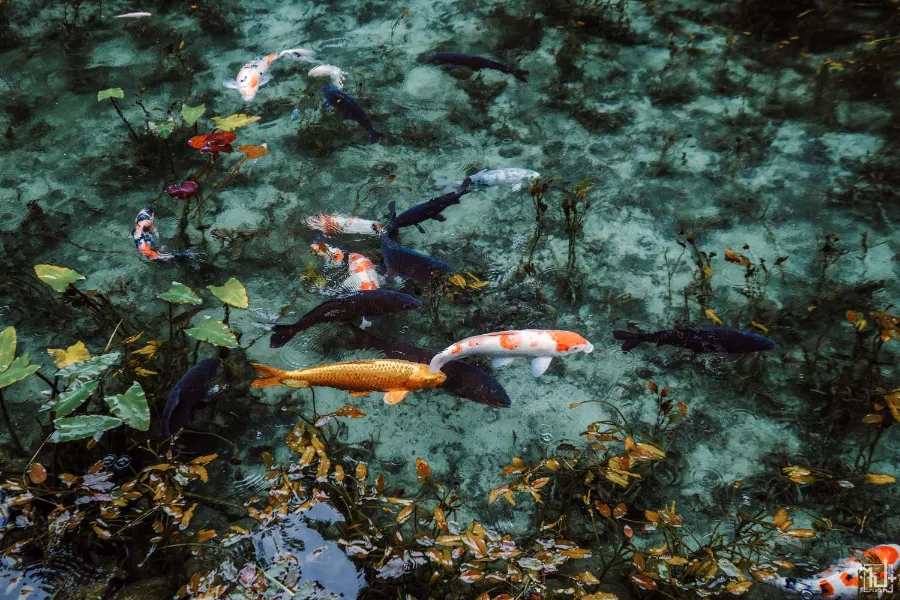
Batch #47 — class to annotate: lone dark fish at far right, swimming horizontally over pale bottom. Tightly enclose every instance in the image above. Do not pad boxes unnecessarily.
[613,329,775,354]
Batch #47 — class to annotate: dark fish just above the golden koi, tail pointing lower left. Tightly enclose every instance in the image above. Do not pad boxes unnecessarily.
[269,290,422,348]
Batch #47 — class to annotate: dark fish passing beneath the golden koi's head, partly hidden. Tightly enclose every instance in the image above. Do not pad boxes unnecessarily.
[343,326,512,408]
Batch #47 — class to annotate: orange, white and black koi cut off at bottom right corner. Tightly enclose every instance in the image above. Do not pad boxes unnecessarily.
[767,544,900,600]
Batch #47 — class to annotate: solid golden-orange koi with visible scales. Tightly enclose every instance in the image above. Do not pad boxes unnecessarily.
[252,359,447,404]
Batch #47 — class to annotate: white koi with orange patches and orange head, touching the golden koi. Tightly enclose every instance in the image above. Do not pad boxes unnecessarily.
[430,329,594,377]
